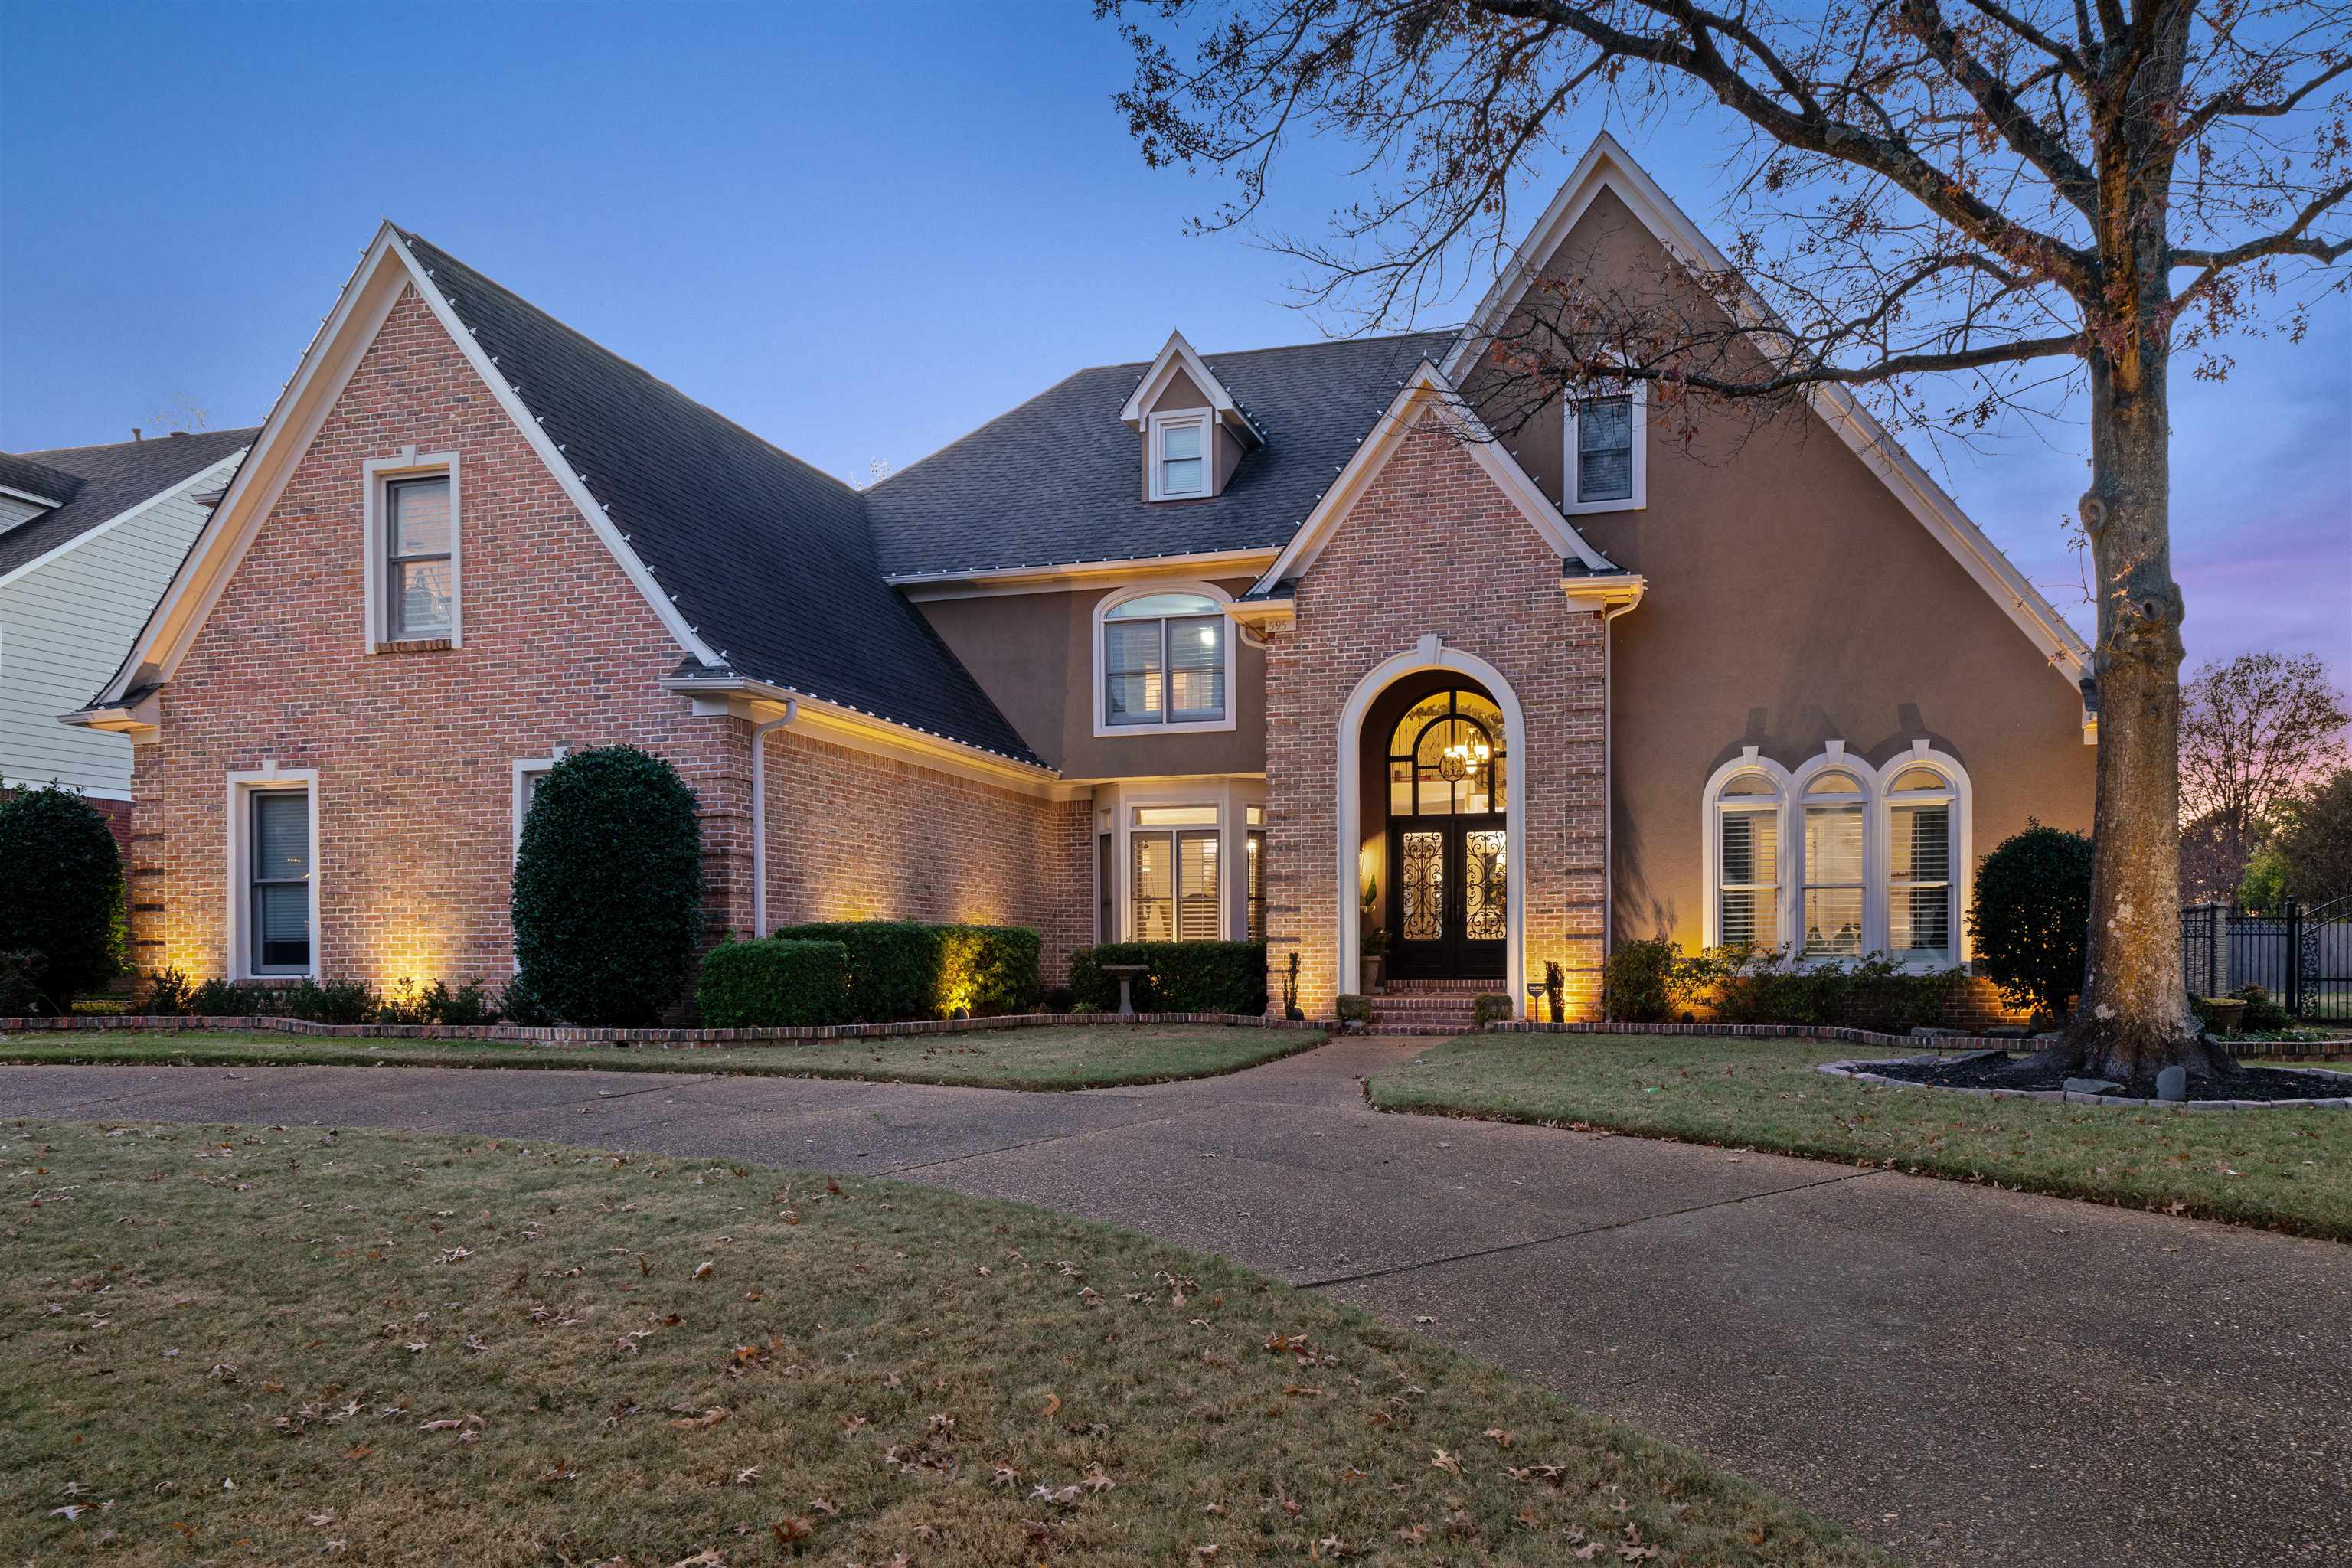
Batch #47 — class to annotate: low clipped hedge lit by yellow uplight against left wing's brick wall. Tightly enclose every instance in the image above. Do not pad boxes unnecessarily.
[776,920,1044,1023]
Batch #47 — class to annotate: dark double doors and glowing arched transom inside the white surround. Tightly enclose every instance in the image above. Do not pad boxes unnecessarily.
[1364,686,1510,982]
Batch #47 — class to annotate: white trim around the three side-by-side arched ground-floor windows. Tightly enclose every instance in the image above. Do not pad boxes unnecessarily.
[1700,740,1975,971]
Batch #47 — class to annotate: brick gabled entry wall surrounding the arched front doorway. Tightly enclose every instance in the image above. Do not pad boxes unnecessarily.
[1266,419,1606,1018]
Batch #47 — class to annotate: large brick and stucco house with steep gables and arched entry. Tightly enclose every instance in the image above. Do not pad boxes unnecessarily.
[70,139,2096,1015]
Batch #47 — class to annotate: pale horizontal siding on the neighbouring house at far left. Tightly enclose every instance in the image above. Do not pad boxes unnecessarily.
[0,456,237,799]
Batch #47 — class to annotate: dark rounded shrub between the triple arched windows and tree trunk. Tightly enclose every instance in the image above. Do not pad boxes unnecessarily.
[1968,818,2098,1018]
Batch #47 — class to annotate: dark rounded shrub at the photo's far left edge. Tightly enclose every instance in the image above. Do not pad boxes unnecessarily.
[0,786,125,1013]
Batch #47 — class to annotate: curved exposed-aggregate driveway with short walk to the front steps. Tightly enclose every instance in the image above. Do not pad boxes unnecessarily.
[0,1039,2352,1563]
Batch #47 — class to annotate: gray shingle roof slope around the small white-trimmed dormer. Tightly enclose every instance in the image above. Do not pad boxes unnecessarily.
[865,332,1453,576]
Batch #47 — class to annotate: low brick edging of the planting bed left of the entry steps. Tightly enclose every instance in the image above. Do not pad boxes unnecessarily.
[0,1013,1329,1048]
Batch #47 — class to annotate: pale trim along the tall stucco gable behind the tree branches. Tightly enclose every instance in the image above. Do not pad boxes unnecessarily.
[1444,132,2091,689]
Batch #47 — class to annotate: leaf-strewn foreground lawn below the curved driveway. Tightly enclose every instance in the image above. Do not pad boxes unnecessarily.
[0,1122,1880,1568]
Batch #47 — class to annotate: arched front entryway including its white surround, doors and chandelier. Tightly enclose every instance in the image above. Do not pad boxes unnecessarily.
[1336,637,1527,1011]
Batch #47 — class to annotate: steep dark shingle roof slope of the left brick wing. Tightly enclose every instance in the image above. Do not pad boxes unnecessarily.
[402,230,1042,766]
